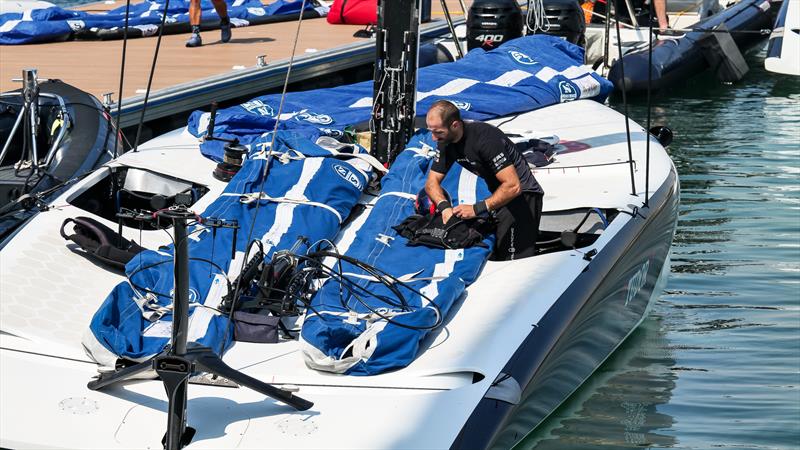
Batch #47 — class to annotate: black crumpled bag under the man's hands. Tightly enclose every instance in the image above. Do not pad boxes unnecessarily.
[392,214,494,249]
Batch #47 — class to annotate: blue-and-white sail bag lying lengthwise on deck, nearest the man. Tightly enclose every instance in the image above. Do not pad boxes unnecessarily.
[301,132,494,375]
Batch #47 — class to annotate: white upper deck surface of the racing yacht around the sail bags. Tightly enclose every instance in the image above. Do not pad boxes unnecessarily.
[0,101,677,449]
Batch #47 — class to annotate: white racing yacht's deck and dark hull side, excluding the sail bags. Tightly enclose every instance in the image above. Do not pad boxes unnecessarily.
[0,101,678,448]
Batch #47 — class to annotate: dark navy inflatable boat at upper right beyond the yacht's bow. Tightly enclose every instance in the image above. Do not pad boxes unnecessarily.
[608,0,778,93]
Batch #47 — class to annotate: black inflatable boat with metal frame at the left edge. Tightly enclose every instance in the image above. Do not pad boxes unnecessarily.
[0,75,116,239]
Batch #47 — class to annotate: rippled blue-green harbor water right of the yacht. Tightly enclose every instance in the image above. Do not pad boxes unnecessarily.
[518,50,800,450]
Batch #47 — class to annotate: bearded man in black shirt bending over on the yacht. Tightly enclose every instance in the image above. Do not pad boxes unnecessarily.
[425,100,544,260]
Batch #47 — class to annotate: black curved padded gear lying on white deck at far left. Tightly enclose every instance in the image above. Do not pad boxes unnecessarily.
[61,217,144,270]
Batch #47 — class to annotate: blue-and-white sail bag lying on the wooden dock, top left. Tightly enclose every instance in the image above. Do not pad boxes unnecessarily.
[0,0,327,45]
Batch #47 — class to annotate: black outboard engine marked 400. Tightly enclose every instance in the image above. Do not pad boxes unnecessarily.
[467,0,522,50]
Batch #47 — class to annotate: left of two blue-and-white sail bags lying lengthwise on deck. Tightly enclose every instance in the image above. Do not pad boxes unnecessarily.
[83,132,371,367]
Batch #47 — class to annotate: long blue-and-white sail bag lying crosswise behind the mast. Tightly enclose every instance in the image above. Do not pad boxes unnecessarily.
[188,35,613,160]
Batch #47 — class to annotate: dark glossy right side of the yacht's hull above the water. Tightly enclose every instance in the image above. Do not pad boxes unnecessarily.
[451,169,679,449]
